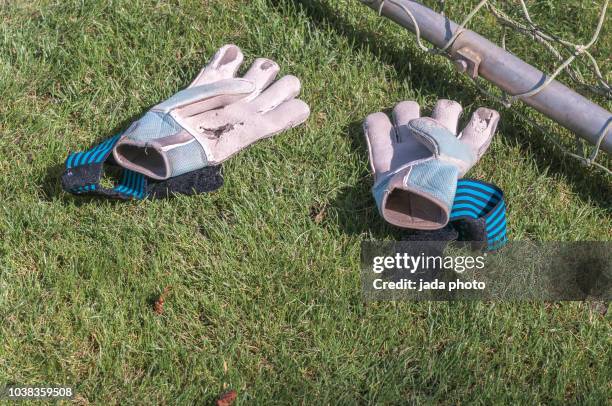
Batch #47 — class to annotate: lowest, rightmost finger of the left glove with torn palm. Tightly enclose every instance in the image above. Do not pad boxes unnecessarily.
[214,99,310,163]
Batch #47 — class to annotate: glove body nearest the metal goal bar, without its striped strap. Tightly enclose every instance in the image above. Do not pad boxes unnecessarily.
[364,100,499,230]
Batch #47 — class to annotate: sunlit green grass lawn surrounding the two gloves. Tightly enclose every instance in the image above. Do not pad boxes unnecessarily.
[0,0,612,404]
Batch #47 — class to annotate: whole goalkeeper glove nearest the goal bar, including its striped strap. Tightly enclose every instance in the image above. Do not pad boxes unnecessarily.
[364,100,506,250]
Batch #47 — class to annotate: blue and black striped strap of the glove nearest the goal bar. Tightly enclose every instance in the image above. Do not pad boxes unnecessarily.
[450,179,508,251]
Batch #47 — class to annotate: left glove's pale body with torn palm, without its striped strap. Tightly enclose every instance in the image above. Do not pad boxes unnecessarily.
[113,45,310,180]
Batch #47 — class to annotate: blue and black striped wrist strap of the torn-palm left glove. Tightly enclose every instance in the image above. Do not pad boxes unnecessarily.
[62,134,223,200]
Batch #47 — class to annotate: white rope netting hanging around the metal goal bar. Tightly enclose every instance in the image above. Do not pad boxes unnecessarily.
[361,0,612,175]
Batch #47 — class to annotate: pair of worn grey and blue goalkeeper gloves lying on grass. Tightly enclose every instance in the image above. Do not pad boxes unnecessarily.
[62,45,505,247]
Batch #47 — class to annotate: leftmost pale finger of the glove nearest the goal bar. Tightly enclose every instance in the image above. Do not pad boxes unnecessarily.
[363,113,396,175]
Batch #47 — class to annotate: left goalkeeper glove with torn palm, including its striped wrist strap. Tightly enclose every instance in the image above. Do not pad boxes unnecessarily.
[62,45,310,199]
